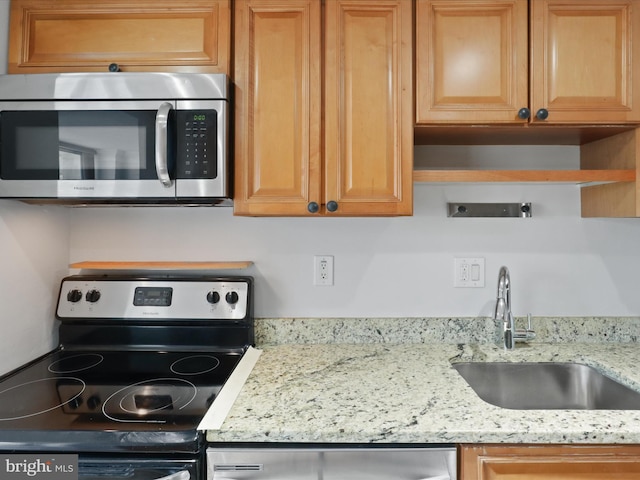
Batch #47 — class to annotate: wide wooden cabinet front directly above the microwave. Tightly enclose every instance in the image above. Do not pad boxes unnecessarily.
[8,0,231,74]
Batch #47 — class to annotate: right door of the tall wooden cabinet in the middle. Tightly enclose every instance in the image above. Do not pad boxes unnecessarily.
[324,0,413,215]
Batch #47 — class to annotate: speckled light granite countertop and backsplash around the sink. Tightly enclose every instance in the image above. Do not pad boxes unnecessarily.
[207,318,640,444]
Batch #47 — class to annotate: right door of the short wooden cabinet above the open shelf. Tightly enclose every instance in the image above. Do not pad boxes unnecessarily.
[530,0,640,123]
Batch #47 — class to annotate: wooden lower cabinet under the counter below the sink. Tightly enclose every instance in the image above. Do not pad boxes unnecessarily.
[460,445,640,480]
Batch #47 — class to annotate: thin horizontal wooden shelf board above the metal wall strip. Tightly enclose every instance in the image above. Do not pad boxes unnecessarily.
[413,169,636,183]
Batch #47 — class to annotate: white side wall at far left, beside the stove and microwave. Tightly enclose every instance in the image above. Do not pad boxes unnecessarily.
[0,0,69,374]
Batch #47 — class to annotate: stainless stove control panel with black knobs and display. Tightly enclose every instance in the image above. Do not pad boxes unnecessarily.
[56,275,253,320]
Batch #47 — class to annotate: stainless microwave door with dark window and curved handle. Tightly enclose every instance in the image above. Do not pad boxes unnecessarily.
[0,100,176,199]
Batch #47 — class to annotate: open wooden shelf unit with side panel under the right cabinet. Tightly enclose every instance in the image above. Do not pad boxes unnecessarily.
[413,125,640,218]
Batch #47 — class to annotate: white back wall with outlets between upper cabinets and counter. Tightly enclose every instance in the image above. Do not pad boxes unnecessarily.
[71,147,640,317]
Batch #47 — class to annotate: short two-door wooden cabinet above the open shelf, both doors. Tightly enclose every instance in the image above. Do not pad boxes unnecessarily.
[416,0,640,125]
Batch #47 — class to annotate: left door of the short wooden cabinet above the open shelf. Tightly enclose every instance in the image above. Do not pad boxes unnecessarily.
[416,0,537,123]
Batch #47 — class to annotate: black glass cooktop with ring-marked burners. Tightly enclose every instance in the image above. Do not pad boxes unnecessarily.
[0,350,242,446]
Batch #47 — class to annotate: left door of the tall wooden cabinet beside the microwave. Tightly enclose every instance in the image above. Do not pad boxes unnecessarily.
[234,0,321,215]
